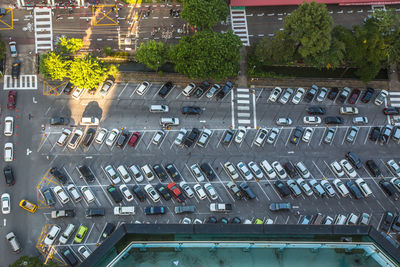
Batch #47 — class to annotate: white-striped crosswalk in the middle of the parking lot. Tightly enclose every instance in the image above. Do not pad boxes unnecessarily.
[233,88,256,128]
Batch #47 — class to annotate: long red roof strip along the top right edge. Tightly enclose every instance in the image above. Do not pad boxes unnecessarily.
[230,0,400,6]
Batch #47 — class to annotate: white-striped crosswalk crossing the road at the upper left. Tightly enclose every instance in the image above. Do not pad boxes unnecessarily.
[33,8,53,53]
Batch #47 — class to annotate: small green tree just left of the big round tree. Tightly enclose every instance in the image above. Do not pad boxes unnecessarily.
[136,40,168,70]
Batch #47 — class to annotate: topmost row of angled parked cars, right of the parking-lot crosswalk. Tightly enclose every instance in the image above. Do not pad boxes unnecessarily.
[268,85,388,106]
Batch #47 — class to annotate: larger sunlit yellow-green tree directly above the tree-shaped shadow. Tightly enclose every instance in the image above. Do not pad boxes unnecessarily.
[69,54,117,90]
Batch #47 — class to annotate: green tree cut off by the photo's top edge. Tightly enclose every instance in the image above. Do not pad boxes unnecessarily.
[181,0,229,30]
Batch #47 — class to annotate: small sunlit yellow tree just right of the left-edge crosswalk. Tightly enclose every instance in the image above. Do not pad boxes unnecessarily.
[39,51,69,80]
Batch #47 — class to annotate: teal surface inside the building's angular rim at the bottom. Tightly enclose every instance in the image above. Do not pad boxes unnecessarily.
[113,248,380,267]
